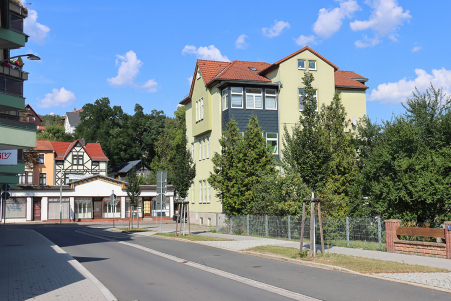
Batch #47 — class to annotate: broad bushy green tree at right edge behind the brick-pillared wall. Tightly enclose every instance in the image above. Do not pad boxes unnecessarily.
[359,86,451,224]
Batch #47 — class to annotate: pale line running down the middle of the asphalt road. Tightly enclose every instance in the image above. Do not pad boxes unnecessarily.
[75,230,320,301]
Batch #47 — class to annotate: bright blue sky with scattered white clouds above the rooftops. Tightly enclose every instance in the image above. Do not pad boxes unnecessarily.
[12,0,451,121]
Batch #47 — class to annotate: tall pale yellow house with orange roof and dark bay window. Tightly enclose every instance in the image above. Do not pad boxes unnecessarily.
[180,46,368,224]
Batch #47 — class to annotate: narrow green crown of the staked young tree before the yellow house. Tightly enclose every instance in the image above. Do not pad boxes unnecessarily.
[282,72,331,198]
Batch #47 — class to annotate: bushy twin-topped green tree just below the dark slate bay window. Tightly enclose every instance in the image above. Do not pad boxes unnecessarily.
[208,116,275,215]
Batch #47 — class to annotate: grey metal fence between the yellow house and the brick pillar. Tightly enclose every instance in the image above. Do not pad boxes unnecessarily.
[216,214,385,249]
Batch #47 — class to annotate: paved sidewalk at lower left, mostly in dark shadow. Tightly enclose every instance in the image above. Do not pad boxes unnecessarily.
[0,229,116,301]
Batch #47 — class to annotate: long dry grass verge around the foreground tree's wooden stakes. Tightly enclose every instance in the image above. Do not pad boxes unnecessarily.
[246,246,449,273]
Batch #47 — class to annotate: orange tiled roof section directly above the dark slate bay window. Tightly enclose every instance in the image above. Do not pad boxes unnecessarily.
[212,61,271,82]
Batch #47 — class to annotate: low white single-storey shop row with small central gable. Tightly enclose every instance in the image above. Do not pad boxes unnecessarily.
[5,175,174,223]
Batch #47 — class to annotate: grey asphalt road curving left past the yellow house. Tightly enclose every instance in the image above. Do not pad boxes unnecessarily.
[27,225,451,301]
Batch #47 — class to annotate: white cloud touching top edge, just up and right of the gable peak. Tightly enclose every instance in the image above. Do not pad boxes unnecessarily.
[313,0,360,39]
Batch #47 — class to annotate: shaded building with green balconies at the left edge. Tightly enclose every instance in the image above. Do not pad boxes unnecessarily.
[0,0,36,187]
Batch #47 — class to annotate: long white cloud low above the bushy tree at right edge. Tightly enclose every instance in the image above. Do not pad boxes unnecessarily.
[368,68,451,104]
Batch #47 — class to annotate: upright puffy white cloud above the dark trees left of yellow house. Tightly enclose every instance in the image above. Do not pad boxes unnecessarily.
[107,50,158,92]
